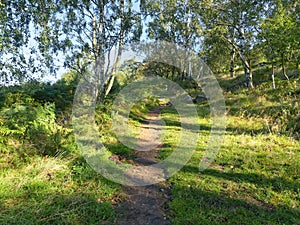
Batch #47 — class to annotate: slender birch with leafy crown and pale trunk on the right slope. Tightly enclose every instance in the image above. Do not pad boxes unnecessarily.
[200,0,265,88]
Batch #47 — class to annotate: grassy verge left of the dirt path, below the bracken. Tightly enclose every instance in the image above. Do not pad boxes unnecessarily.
[0,97,157,225]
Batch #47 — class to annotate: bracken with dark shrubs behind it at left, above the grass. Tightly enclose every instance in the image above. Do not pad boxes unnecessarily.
[0,76,81,155]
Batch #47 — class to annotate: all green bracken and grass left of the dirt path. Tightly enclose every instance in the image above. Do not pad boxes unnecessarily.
[0,77,119,224]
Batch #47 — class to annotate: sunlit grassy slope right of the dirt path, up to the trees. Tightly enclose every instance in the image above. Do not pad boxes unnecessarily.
[162,75,300,225]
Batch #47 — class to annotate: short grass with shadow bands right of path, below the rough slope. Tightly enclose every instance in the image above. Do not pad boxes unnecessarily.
[169,133,300,224]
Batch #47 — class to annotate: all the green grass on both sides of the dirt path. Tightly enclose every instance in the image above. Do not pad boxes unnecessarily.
[0,71,300,225]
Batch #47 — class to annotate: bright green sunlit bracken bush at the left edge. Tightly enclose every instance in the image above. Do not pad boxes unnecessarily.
[0,94,75,155]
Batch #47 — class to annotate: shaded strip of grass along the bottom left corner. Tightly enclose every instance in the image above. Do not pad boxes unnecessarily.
[0,190,115,225]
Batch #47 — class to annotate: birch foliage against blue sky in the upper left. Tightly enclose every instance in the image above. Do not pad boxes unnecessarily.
[0,0,142,87]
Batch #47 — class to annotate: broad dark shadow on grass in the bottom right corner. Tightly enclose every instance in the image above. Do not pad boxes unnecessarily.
[169,184,300,225]
